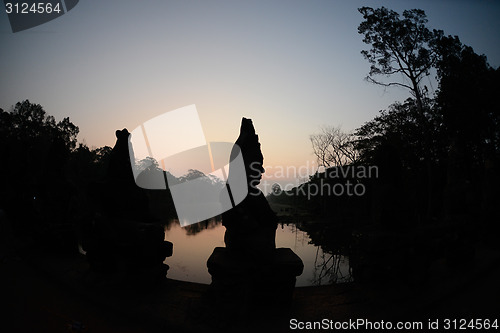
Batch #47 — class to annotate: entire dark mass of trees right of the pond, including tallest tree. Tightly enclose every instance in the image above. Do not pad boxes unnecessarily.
[268,7,500,285]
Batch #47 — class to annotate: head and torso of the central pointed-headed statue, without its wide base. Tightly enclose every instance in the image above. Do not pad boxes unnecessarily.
[222,118,278,257]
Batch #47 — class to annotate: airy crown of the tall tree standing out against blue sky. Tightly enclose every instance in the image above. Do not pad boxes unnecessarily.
[358,7,442,113]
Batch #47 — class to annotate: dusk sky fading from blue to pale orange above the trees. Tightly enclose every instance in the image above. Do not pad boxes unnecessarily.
[0,0,500,188]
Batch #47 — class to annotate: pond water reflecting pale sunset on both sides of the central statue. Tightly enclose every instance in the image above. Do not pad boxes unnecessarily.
[165,219,352,286]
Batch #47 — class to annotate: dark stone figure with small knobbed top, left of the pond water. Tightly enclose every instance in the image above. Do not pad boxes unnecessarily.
[84,129,173,287]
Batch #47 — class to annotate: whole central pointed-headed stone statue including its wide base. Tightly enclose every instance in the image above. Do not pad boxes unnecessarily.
[207,118,304,320]
